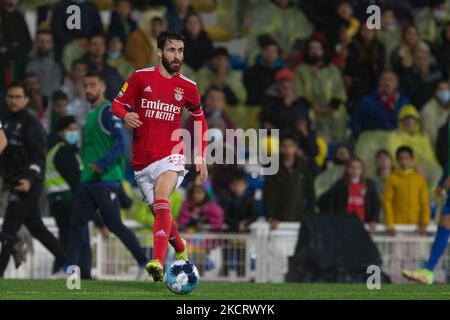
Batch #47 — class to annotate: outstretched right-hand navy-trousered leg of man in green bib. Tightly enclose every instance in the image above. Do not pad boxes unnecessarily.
[92,186,147,267]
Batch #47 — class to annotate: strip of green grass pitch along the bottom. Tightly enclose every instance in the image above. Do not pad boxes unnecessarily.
[0,280,450,300]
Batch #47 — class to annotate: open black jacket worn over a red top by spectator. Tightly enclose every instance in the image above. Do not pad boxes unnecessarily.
[326,178,380,222]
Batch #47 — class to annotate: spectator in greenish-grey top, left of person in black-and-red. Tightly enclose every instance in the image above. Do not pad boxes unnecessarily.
[314,144,352,208]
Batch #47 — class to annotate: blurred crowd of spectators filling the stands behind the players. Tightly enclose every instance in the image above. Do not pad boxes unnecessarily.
[0,0,450,276]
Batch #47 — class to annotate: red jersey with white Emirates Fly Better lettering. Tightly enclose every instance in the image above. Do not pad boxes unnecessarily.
[112,66,206,171]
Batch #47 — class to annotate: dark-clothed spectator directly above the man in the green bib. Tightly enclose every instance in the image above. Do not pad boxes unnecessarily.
[82,34,123,101]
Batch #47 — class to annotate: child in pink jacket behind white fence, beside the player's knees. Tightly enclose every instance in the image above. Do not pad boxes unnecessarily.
[178,185,224,232]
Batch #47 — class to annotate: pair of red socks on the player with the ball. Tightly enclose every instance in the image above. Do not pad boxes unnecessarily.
[152,199,184,265]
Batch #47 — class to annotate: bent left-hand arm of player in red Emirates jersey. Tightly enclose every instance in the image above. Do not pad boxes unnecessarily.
[111,72,142,128]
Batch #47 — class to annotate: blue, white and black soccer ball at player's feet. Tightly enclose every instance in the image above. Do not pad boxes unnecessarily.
[164,260,200,294]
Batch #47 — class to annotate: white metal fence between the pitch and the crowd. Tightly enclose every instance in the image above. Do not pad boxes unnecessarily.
[5,221,450,283]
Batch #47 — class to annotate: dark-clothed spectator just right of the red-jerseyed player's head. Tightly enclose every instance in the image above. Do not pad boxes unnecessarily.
[182,13,214,71]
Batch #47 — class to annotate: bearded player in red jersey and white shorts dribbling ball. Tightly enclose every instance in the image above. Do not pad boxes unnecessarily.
[112,31,208,281]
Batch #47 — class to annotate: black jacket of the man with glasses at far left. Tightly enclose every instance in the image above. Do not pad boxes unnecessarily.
[3,109,46,186]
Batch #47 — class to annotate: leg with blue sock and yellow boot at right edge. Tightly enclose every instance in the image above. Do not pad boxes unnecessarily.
[402,208,450,284]
